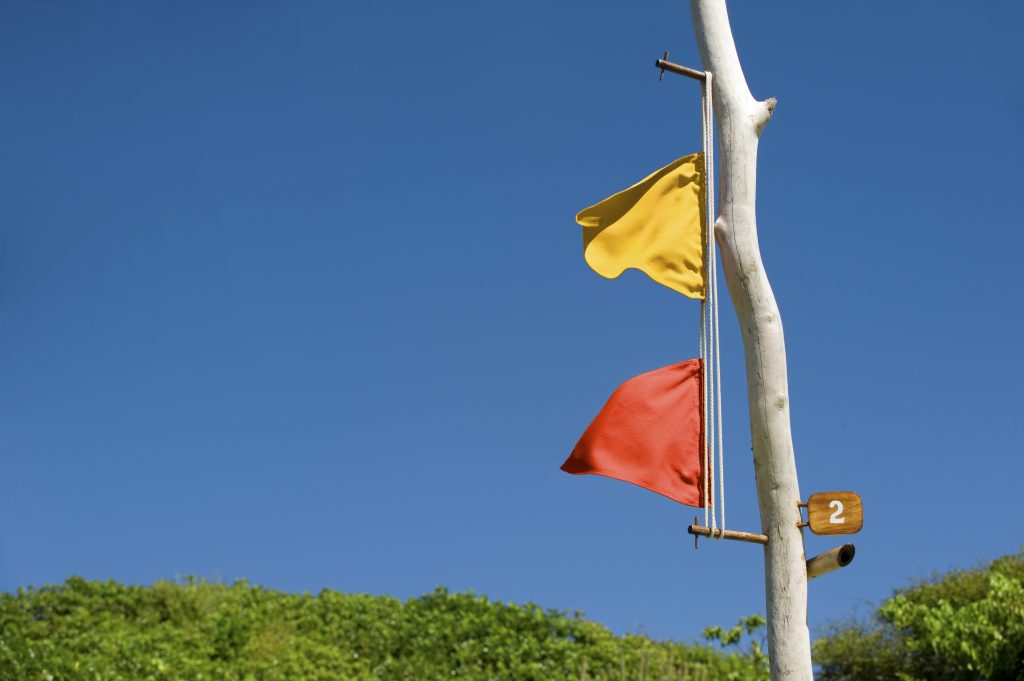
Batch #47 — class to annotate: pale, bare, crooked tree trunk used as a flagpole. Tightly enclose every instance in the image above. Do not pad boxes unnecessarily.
[690,0,813,681]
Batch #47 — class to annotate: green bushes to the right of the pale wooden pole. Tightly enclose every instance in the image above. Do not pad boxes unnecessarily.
[814,553,1024,681]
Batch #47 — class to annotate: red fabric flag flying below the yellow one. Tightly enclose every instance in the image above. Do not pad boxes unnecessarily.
[562,359,705,507]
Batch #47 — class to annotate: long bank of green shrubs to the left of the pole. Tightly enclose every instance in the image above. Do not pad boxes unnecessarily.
[0,578,767,681]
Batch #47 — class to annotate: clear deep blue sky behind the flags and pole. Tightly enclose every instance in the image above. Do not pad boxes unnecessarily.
[0,0,1024,639]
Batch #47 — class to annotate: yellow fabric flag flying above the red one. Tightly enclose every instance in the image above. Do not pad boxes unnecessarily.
[577,154,706,299]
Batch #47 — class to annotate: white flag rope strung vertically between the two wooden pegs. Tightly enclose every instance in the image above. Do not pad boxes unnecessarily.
[701,72,725,539]
